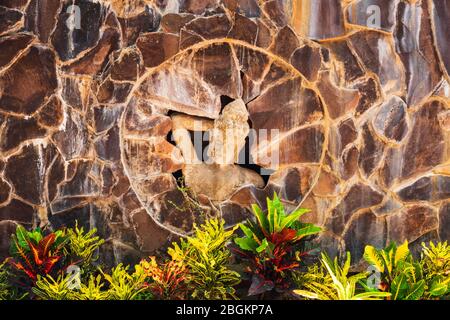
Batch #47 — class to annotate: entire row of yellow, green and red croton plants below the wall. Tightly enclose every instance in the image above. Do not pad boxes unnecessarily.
[0,200,450,300]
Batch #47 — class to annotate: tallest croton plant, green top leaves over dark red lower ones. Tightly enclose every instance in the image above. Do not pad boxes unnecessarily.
[235,194,321,296]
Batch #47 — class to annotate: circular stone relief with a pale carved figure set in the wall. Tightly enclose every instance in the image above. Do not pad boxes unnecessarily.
[120,39,328,235]
